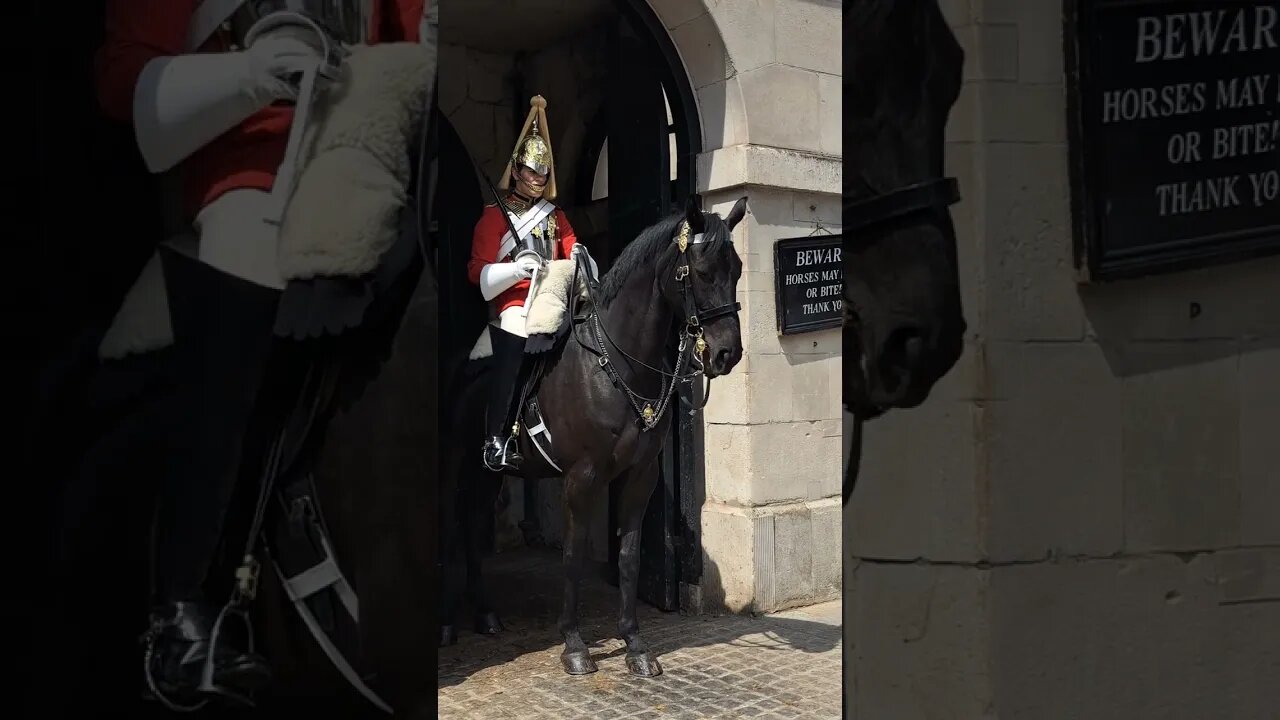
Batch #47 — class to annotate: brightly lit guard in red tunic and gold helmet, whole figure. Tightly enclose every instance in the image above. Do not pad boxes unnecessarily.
[467,95,594,473]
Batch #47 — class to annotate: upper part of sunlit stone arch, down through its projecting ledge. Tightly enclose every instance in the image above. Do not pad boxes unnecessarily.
[636,0,842,195]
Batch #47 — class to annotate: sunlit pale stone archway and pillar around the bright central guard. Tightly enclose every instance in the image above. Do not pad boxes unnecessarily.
[439,0,842,610]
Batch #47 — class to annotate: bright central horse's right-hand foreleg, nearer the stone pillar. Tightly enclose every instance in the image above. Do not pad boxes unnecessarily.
[618,462,662,678]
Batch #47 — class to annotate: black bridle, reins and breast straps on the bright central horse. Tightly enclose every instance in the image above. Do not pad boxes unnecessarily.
[570,220,742,432]
